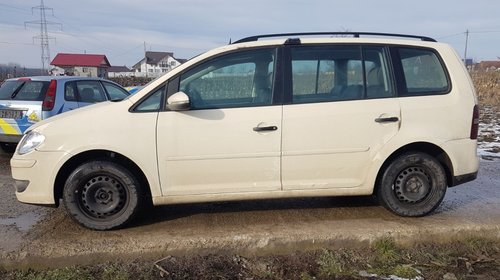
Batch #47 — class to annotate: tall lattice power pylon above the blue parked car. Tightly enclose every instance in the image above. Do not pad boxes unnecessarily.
[24,0,62,75]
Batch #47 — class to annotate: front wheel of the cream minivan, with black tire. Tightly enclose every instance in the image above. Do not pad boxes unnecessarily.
[63,161,142,230]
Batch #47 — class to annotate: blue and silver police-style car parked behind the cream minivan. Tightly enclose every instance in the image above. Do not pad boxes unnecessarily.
[0,76,129,151]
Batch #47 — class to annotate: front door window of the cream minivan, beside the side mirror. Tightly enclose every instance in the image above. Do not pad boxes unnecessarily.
[179,49,275,109]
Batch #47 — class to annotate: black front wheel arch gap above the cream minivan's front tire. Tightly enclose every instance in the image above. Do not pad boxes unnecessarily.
[54,150,152,206]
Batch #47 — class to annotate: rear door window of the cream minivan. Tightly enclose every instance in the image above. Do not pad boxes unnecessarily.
[291,45,394,103]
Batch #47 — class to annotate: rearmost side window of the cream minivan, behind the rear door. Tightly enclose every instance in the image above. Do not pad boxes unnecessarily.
[398,48,450,96]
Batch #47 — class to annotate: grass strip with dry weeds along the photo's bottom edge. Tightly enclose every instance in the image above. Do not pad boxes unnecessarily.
[0,237,500,280]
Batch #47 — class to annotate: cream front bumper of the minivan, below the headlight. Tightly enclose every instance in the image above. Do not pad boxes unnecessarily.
[10,151,68,206]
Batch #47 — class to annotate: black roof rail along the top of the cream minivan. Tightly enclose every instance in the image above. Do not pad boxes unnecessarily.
[233,32,437,44]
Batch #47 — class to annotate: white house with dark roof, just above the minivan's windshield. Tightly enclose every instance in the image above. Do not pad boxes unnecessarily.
[132,52,187,77]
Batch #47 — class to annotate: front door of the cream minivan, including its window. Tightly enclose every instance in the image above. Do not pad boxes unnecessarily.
[157,49,282,195]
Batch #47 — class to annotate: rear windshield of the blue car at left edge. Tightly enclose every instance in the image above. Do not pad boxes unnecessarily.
[0,80,49,101]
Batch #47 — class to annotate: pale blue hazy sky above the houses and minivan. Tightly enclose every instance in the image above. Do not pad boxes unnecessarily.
[0,0,500,68]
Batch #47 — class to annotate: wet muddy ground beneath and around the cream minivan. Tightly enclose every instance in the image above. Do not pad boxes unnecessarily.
[0,106,500,278]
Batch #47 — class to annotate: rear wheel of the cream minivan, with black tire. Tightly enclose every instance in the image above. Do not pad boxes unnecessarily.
[377,152,447,217]
